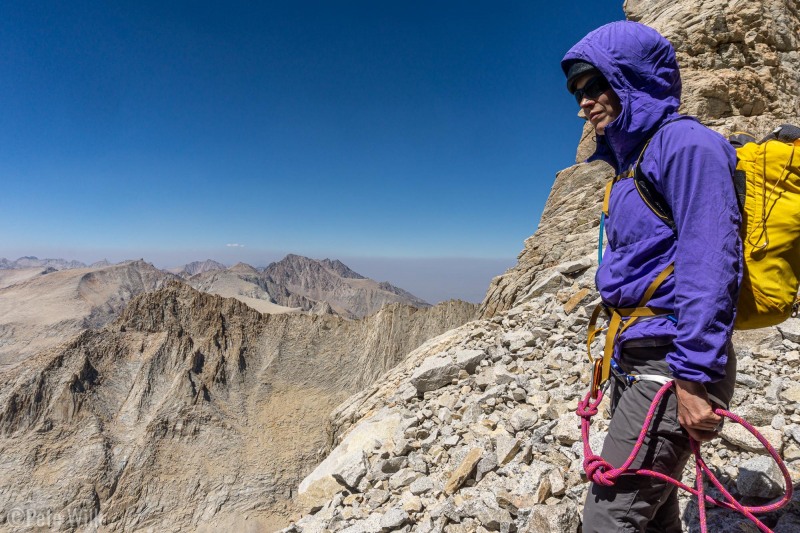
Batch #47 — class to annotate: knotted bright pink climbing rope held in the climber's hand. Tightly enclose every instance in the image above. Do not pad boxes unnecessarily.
[577,381,793,533]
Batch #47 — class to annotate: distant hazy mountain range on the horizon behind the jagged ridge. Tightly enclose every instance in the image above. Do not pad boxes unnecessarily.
[0,255,438,368]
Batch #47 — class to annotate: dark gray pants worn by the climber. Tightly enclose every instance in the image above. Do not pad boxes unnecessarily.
[583,344,736,533]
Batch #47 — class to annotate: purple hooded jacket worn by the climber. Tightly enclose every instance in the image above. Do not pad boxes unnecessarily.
[561,22,742,383]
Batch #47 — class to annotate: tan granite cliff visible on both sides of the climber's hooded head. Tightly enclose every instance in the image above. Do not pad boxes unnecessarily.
[481,0,800,317]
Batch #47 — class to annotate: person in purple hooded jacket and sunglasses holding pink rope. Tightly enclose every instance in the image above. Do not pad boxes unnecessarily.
[561,22,742,533]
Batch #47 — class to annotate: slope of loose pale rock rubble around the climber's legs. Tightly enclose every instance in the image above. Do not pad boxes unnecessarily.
[283,260,800,533]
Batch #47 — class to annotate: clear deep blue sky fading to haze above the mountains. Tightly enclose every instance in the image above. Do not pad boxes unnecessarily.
[0,0,624,301]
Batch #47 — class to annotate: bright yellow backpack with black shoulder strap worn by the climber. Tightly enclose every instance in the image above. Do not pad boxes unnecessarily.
[634,124,800,329]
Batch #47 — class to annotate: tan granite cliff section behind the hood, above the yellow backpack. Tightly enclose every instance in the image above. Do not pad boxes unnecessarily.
[625,0,800,136]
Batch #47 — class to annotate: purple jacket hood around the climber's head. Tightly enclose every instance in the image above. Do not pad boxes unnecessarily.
[561,21,681,170]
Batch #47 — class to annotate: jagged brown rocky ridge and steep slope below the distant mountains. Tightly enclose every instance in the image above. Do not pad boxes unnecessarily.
[0,281,476,531]
